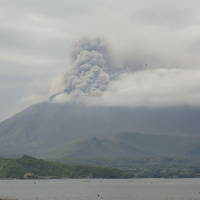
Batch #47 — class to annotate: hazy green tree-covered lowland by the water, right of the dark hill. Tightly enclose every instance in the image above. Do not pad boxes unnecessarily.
[65,156,200,178]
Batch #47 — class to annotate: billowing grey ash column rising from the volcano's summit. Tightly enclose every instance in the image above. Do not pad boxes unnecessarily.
[51,38,113,102]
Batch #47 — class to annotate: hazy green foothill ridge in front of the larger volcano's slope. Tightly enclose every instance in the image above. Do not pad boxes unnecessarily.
[48,133,200,162]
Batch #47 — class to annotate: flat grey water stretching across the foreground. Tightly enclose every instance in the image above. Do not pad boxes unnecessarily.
[0,179,200,200]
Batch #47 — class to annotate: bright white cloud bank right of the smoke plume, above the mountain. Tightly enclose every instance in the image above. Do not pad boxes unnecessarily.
[101,68,200,107]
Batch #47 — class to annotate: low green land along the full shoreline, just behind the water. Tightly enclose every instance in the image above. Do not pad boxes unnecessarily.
[0,156,200,179]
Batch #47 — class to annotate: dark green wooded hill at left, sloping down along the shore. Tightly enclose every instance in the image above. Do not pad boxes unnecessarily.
[0,156,131,178]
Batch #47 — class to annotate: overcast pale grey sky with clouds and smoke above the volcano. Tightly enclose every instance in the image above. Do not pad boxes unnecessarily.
[0,0,200,120]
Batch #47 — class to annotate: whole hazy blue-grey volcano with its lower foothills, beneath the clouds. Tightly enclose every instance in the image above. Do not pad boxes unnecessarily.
[0,103,200,158]
